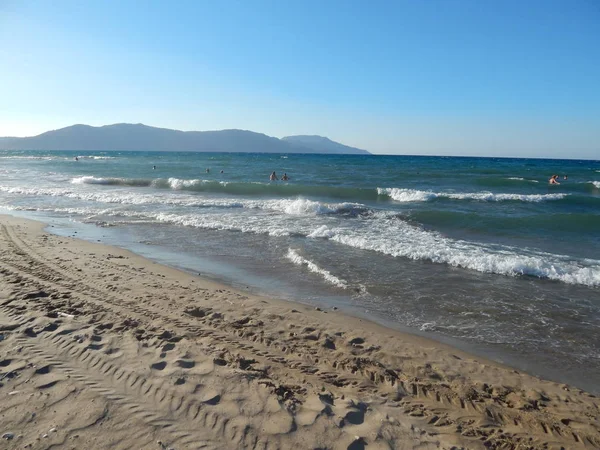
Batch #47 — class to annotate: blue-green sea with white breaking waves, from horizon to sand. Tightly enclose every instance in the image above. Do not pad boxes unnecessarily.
[0,151,600,394]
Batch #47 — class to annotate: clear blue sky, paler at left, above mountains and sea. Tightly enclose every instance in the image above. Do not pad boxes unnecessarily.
[0,0,600,159]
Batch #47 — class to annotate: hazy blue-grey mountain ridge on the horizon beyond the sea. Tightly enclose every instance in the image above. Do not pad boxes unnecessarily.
[0,123,368,154]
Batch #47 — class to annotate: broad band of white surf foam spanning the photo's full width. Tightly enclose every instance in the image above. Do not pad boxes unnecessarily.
[0,181,600,286]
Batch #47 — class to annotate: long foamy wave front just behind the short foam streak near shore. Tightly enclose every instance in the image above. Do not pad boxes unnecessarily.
[9,195,600,287]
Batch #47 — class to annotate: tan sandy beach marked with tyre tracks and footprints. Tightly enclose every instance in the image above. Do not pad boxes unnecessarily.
[0,216,600,450]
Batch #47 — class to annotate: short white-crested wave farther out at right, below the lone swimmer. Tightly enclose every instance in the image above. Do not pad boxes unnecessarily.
[377,188,569,203]
